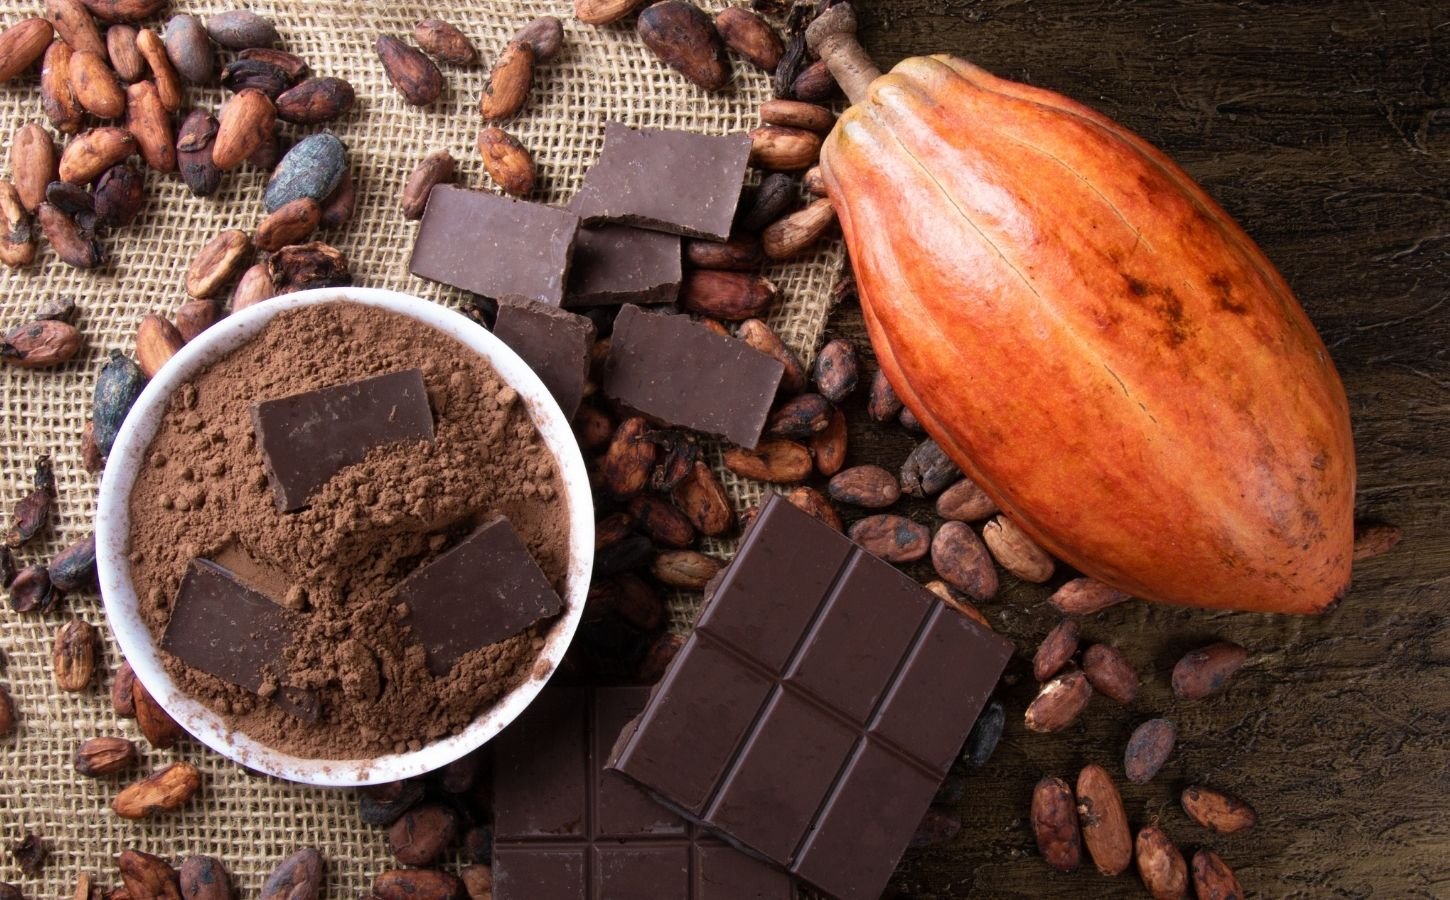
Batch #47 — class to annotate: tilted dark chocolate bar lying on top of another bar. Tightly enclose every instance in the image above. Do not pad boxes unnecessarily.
[610,497,1012,900]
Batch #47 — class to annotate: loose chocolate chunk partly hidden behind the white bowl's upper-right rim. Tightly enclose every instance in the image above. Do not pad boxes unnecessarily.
[493,297,595,419]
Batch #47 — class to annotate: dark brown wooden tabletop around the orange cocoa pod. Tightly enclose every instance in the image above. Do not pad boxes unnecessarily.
[832,0,1450,900]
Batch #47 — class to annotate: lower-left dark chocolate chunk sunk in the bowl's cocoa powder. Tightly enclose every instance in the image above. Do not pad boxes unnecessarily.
[161,559,319,722]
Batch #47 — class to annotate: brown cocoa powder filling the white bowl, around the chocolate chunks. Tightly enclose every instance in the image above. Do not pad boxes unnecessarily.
[131,303,568,758]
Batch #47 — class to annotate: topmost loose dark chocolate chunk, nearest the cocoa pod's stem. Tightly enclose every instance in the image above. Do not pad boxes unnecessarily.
[570,122,751,241]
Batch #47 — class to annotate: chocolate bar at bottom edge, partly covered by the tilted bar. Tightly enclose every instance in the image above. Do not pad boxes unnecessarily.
[493,687,796,900]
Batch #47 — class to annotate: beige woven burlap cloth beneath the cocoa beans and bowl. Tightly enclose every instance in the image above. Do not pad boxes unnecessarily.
[0,0,841,899]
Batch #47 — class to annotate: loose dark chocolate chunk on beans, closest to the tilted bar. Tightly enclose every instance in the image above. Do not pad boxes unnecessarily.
[603,306,784,448]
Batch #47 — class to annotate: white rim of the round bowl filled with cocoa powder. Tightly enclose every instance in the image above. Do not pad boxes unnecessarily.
[96,287,595,787]
